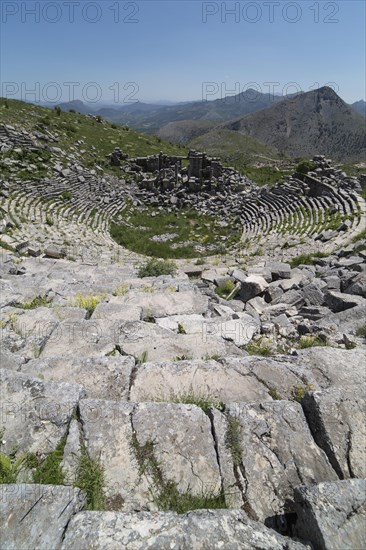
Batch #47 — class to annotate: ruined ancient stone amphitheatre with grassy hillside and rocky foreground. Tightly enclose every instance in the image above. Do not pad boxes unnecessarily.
[0,100,366,550]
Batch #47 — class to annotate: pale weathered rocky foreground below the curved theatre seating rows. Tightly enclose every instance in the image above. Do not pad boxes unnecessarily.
[0,241,366,550]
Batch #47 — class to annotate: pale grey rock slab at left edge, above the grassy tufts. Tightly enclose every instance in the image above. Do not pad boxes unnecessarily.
[0,370,84,453]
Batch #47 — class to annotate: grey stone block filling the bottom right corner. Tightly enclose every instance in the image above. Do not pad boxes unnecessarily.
[295,479,366,550]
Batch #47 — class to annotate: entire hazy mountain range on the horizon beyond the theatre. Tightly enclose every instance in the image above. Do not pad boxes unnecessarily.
[54,87,366,161]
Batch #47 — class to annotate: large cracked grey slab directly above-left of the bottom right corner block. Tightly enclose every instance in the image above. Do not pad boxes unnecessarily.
[214,401,338,526]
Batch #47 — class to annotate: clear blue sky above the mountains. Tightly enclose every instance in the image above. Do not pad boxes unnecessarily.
[0,0,366,104]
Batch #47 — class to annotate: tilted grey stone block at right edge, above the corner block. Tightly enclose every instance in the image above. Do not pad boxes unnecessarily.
[302,386,366,479]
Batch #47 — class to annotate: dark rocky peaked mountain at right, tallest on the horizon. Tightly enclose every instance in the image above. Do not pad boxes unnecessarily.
[220,86,366,160]
